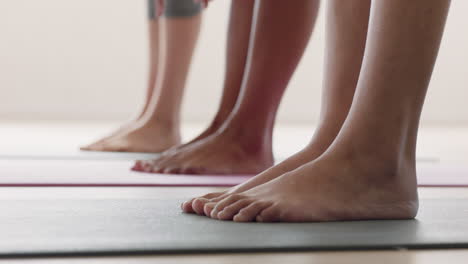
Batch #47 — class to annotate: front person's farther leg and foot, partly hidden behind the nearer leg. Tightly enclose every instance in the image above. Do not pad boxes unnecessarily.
[182,0,370,215]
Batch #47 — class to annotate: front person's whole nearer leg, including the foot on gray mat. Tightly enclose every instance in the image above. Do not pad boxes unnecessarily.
[206,0,450,222]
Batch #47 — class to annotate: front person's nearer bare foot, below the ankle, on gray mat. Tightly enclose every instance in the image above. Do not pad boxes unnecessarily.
[192,151,418,222]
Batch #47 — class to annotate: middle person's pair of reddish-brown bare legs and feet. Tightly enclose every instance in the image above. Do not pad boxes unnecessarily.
[134,0,319,174]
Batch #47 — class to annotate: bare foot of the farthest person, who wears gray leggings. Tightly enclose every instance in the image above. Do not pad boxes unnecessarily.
[81,120,180,153]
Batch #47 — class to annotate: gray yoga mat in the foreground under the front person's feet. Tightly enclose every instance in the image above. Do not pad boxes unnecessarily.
[0,199,468,257]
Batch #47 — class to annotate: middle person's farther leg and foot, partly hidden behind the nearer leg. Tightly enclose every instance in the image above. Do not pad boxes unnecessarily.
[133,1,254,172]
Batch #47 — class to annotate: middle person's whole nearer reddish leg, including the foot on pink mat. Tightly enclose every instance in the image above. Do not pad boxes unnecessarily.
[139,0,318,177]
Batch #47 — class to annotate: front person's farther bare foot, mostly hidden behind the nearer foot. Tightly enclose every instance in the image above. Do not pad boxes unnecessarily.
[182,146,322,216]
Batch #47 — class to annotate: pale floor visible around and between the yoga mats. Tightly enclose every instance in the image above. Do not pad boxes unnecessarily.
[0,123,468,264]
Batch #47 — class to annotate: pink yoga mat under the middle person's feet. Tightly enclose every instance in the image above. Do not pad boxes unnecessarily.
[0,160,468,187]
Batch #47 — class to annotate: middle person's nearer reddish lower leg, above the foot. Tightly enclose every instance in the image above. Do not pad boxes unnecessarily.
[221,0,319,155]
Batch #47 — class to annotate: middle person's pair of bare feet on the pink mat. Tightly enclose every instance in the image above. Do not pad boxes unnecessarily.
[133,128,273,175]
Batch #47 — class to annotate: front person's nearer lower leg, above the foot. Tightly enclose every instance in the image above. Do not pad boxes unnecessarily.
[328,0,450,170]
